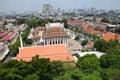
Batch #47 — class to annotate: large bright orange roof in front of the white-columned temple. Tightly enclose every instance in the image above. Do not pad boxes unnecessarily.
[16,44,74,62]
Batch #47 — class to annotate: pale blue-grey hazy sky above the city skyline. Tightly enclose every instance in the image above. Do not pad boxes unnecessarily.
[0,0,120,12]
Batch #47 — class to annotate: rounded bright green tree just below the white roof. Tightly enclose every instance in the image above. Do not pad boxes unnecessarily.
[77,54,100,74]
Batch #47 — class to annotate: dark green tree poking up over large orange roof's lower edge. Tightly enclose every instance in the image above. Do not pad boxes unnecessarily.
[31,56,54,80]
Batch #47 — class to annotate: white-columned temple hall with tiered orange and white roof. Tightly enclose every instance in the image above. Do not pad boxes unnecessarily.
[43,23,69,45]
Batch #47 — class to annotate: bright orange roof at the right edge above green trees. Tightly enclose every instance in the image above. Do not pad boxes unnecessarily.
[102,32,119,41]
